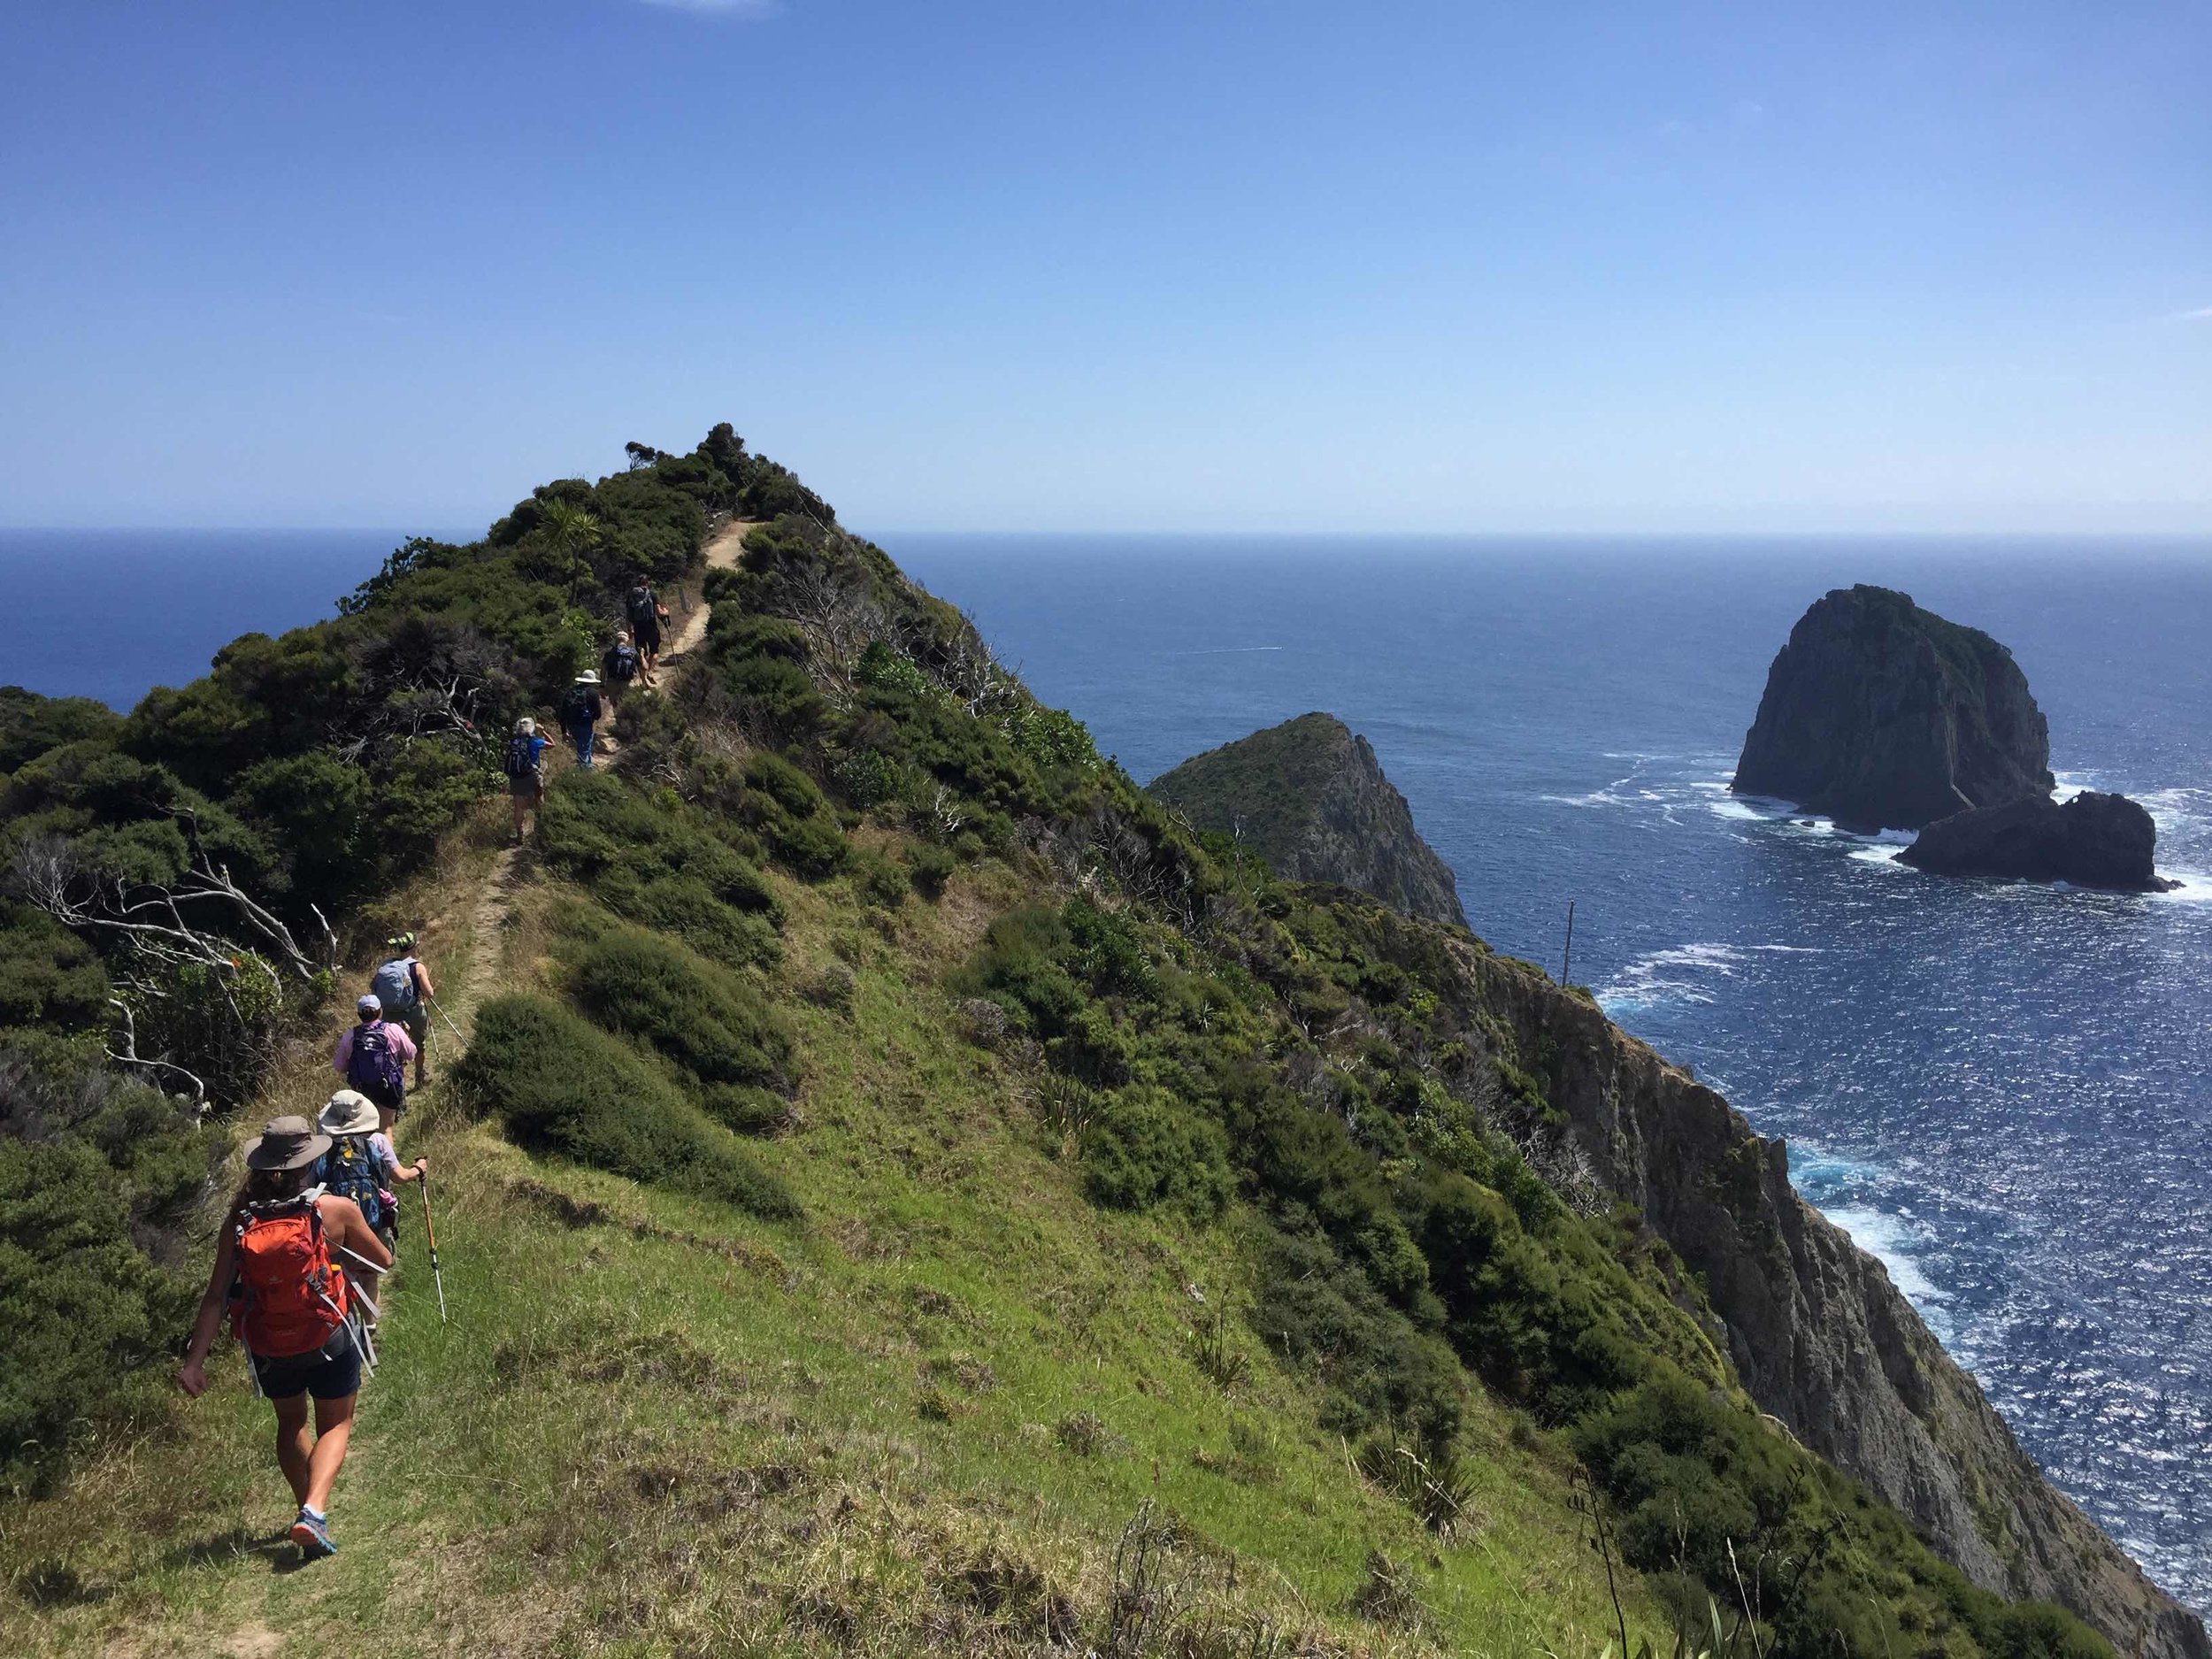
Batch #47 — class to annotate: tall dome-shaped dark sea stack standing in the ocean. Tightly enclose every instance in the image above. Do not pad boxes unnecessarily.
[1730,584,2053,830]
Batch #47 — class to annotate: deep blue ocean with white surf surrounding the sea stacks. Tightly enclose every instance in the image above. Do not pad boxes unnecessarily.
[12,531,2212,1610]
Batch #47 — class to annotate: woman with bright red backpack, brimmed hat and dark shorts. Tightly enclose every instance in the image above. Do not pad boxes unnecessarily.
[177,1118,392,1562]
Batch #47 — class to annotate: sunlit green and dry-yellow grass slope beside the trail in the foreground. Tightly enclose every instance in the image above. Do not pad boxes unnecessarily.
[0,814,1655,1653]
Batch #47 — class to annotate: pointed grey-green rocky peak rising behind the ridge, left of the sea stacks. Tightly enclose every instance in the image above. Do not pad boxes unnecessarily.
[1146,715,1467,927]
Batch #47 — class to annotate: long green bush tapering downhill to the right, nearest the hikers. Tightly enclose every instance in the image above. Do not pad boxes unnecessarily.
[454,995,799,1219]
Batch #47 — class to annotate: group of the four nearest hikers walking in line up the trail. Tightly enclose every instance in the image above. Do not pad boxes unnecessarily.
[177,933,445,1560]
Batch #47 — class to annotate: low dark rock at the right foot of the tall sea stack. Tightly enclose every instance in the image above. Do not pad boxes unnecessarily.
[1898,792,2181,894]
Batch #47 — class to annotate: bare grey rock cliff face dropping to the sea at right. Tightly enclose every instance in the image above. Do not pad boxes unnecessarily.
[1460,951,2212,1659]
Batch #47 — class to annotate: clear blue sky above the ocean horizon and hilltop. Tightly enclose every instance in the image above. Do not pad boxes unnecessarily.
[0,0,2212,534]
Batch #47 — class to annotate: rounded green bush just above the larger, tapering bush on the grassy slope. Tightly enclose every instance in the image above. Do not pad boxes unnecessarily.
[573,927,795,1091]
